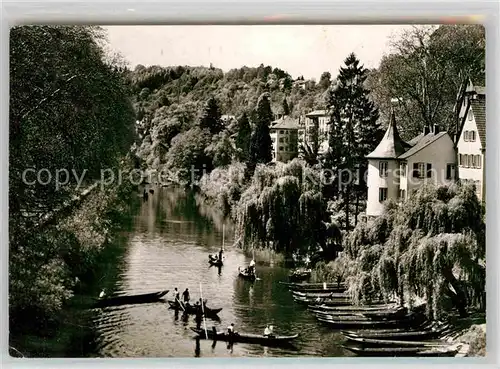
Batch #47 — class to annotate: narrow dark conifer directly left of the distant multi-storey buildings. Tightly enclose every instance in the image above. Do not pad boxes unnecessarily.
[250,92,273,166]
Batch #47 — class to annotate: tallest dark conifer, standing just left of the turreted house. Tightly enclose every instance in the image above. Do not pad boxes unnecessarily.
[326,54,381,229]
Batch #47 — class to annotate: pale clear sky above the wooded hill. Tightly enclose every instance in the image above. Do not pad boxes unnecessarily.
[104,25,410,80]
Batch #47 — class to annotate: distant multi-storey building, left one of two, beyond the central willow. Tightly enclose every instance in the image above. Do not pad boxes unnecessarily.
[270,116,299,162]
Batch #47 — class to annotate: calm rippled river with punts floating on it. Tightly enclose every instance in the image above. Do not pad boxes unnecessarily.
[86,187,349,357]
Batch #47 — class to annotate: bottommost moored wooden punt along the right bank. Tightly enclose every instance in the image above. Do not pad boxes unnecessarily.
[342,345,459,357]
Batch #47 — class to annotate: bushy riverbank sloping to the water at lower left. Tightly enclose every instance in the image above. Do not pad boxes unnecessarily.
[9,184,140,357]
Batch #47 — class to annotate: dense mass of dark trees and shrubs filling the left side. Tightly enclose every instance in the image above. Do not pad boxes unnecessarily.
[9,26,135,329]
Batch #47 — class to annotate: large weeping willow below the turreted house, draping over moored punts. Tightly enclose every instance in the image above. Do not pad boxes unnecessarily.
[344,184,486,317]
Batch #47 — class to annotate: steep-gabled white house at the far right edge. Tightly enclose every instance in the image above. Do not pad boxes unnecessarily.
[456,83,486,202]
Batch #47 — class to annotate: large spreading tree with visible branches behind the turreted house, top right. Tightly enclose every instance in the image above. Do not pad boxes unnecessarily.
[369,25,485,139]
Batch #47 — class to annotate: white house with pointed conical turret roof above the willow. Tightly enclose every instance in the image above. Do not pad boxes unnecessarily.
[366,112,456,217]
